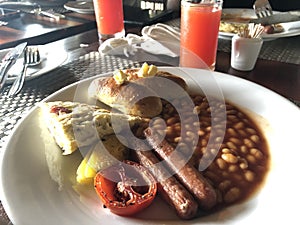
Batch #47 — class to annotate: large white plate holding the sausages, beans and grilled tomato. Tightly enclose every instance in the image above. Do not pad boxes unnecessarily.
[0,67,300,225]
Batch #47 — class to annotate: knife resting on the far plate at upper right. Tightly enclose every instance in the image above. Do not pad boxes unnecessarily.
[250,12,300,25]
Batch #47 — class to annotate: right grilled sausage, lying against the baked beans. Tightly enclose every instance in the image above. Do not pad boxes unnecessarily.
[144,128,217,210]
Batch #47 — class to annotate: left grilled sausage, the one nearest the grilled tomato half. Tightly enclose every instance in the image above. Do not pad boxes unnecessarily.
[133,142,198,219]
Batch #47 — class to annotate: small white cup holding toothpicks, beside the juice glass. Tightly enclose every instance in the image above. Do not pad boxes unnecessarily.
[231,34,263,71]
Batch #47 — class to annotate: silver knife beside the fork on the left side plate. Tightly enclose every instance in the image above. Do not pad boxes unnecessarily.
[0,42,27,90]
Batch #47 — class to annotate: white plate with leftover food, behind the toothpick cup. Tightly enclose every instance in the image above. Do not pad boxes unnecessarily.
[219,8,300,41]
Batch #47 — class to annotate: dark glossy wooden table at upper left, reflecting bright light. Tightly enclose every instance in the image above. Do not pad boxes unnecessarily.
[0,9,96,49]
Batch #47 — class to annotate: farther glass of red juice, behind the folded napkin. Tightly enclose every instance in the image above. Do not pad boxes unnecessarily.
[93,0,125,41]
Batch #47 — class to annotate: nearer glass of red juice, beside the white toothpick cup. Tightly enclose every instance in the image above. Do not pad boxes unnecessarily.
[180,0,223,70]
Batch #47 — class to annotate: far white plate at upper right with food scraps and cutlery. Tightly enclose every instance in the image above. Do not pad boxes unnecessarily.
[219,8,300,41]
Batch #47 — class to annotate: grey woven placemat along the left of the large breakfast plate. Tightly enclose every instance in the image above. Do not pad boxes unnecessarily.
[0,52,141,151]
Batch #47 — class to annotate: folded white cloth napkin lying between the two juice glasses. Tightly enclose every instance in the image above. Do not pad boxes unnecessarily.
[98,24,180,57]
